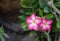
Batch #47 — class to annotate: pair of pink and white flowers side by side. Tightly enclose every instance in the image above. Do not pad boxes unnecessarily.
[26,14,52,31]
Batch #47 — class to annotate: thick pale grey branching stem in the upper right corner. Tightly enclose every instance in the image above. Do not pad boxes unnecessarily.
[46,0,60,21]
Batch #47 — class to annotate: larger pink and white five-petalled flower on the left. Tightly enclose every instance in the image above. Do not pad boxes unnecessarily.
[26,14,41,31]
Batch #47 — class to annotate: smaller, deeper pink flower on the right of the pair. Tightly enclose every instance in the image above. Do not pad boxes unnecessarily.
[39,19,52,31]
